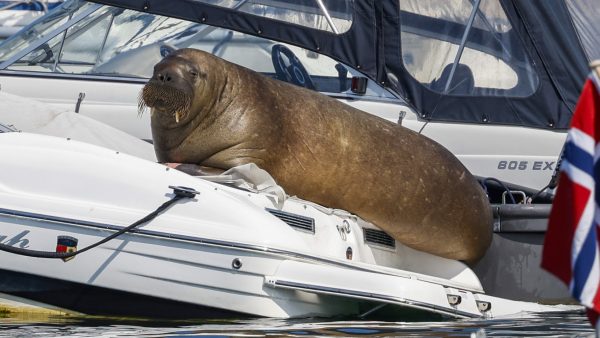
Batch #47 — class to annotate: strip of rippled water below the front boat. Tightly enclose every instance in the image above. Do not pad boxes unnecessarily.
[0,312,594,338]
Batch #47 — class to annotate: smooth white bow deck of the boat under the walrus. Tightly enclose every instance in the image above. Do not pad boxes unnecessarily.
[0,133,309,253]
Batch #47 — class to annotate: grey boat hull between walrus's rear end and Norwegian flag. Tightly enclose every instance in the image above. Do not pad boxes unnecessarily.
[473,204,574,304]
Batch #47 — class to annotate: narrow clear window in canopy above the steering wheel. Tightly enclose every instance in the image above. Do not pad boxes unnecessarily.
[196,0,354,34]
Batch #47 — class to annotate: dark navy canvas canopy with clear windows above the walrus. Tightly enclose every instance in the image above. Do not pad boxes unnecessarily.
[94,0,600,129]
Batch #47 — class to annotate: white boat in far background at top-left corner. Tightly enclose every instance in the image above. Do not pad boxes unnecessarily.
[0,0,64,40]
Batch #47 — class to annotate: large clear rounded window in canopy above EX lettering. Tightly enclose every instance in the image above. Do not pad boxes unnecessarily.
[399,0,538,97]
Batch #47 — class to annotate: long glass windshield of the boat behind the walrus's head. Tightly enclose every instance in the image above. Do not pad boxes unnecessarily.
[0,0,351,92]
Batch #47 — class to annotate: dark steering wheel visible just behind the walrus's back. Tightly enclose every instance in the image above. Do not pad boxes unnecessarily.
[271,45,315,90]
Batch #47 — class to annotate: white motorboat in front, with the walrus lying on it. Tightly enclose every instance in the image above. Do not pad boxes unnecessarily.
[0,132,576,318]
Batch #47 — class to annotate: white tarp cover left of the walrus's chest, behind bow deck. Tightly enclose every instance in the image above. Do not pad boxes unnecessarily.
[0,92,156,162]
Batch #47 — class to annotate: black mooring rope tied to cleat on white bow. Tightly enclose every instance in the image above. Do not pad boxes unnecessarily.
[0,187,197,259]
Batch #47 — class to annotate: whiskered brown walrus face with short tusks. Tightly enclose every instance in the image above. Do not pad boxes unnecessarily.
[138,53,205,129]
